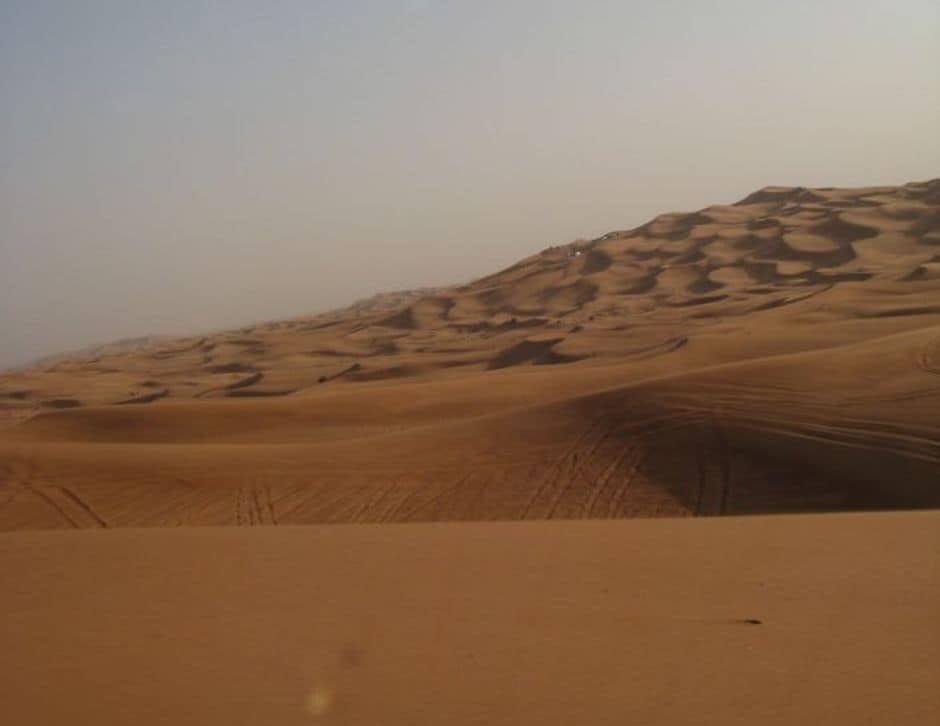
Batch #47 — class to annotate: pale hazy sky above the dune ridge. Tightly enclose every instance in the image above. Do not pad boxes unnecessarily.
[0,0,940,366]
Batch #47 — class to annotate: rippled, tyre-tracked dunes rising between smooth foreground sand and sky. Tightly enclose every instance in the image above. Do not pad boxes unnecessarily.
[0,181,940,529]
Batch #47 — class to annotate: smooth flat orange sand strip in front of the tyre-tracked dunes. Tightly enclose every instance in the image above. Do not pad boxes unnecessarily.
[0,512,940,726]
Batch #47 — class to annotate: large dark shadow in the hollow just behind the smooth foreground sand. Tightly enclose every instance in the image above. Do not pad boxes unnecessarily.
[644,416,940,516]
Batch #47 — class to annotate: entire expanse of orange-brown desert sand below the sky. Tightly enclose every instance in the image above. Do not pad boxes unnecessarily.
[0,180,940,726]
